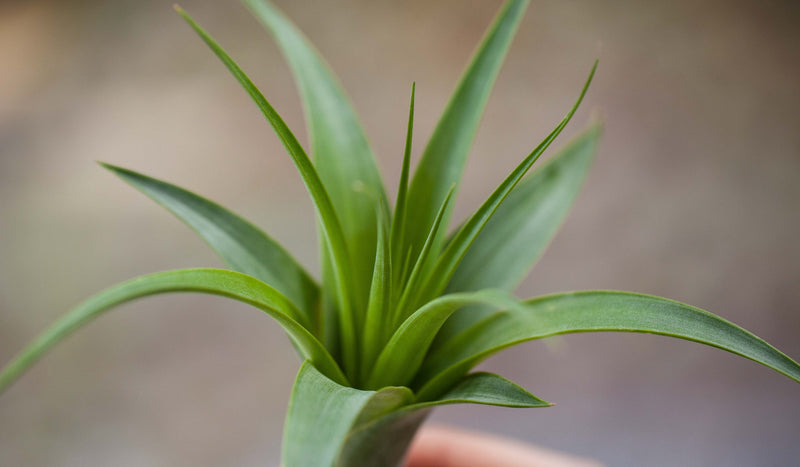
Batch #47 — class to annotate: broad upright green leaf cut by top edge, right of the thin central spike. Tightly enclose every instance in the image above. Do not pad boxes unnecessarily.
[405,0,528,266]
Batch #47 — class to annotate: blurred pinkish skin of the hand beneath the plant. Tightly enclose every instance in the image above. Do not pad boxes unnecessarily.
[408,426,602,467]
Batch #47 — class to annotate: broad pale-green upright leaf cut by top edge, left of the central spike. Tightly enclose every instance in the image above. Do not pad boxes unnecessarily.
[245,0,388,309]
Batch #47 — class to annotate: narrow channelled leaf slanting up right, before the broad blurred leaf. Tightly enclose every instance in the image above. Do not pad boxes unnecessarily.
[412,62,597,310]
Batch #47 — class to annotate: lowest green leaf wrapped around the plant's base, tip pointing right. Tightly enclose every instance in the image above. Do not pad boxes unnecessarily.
[290,362,550,467]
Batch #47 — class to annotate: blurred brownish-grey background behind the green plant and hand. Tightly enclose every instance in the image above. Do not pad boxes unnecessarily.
[0,0,800,466]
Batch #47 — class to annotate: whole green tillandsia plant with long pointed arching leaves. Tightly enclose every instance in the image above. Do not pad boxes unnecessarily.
[0,0,800,467]
